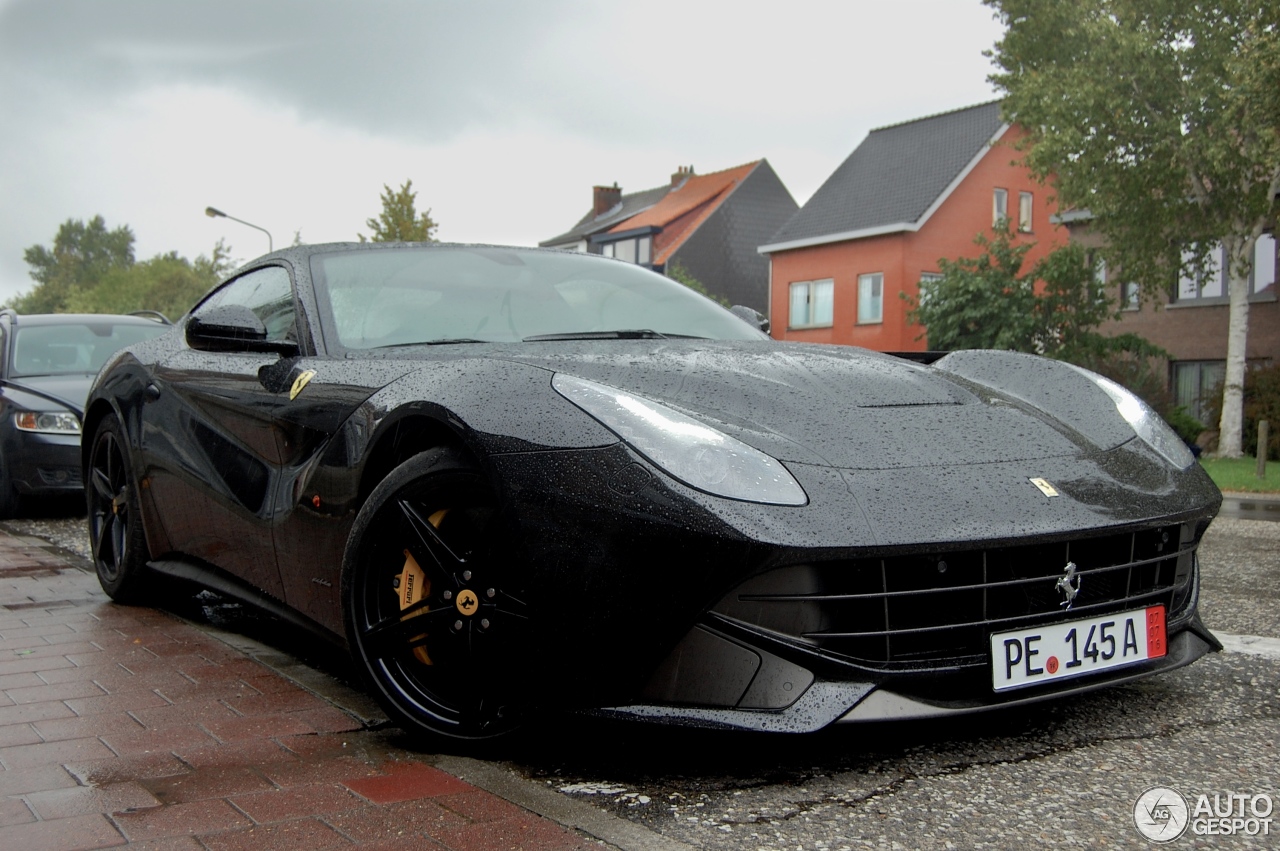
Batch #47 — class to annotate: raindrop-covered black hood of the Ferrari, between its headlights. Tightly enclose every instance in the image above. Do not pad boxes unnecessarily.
[496,340,1097,470]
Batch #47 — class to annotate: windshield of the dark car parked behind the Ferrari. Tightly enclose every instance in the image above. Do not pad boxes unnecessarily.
[9,317,169,378]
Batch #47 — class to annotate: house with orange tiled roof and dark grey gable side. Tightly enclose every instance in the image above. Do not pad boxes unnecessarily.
[538,160,797,312]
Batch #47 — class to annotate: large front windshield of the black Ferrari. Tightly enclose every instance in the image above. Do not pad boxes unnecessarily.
[311,246,765,349]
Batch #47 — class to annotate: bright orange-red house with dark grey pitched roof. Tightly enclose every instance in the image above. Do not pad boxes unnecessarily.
[759,102,1068,352]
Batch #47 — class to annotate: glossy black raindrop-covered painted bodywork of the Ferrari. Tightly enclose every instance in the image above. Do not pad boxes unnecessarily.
[87,241,1219,729]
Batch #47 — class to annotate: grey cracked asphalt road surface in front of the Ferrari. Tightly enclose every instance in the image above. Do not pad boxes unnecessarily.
[10,506,1280,851]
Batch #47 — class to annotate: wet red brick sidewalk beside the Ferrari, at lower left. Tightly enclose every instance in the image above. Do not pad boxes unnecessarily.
[0,530,599,851]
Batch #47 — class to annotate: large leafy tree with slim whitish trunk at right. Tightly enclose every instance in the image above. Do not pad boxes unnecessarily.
[984,0,1280,457]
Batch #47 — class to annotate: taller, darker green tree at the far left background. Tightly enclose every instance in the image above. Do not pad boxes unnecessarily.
[10,216,133,314]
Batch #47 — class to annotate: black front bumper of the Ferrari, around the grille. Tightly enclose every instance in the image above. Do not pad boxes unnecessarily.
[490,441,1220,732]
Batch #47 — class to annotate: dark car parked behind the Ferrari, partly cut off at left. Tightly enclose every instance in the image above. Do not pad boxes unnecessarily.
[0,310,169,517]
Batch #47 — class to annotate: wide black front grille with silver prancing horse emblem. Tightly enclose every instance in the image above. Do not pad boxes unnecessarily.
[714,525,1197,668]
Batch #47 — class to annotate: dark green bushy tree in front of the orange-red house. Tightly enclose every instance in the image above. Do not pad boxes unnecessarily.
[904,221,1160,363]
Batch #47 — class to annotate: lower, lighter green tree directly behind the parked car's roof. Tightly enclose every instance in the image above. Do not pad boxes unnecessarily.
[67,239,232,320]
